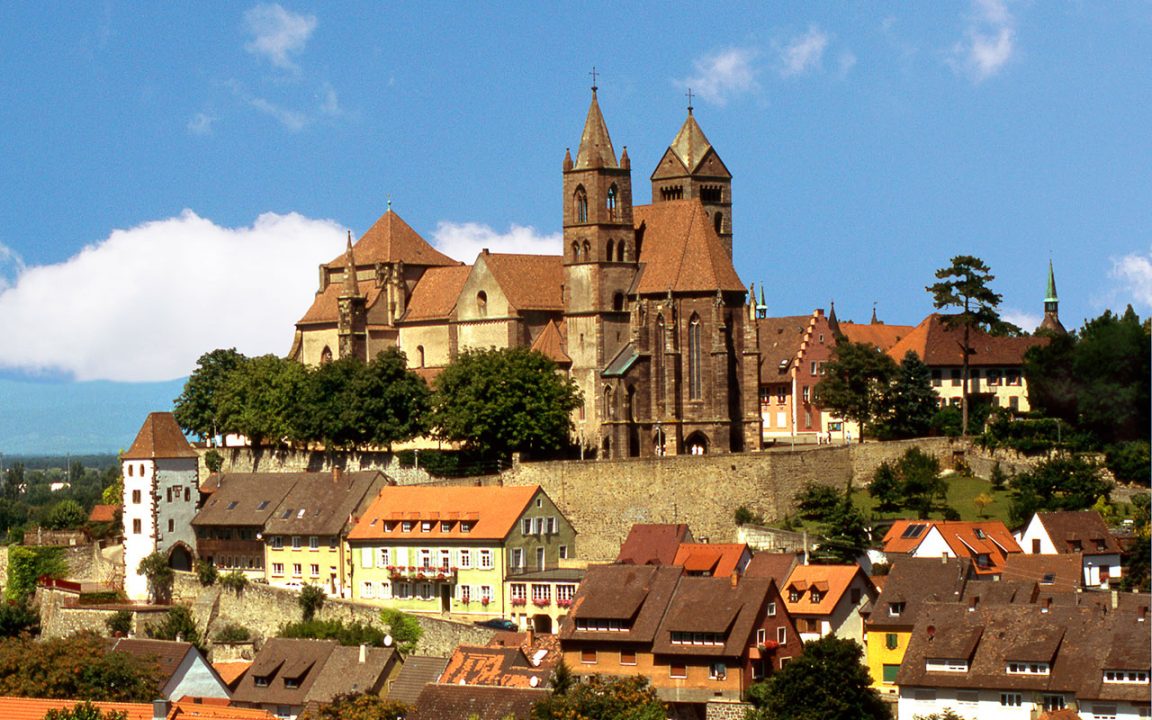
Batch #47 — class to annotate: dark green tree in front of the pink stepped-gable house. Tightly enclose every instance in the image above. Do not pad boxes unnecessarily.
[816,342,897,442]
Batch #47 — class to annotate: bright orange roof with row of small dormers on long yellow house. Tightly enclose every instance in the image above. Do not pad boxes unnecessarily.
[348,485,541,543]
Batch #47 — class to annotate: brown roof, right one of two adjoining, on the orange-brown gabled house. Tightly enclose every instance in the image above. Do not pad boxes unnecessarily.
[652,576,773,658]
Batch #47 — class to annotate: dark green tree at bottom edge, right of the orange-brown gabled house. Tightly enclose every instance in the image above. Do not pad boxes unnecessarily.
[748,635,892,720]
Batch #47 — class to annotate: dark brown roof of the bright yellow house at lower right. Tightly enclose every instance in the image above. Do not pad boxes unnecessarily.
[869,558,972,630]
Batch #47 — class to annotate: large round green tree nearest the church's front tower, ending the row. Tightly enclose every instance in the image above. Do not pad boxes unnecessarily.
[432,348,579,457]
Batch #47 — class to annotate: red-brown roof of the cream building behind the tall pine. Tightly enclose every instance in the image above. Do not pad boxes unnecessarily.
[880,313,1047,367]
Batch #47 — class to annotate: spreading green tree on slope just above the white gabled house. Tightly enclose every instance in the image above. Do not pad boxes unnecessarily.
[1008,455,1112,524]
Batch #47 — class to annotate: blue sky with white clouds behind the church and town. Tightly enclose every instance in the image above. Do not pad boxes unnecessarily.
[0,0,1152,453]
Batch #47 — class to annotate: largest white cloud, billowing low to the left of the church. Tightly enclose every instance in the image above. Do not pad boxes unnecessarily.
[0,210,344,381]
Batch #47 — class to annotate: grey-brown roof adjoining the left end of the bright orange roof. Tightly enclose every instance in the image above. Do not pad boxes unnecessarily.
[264,470,392,536]
